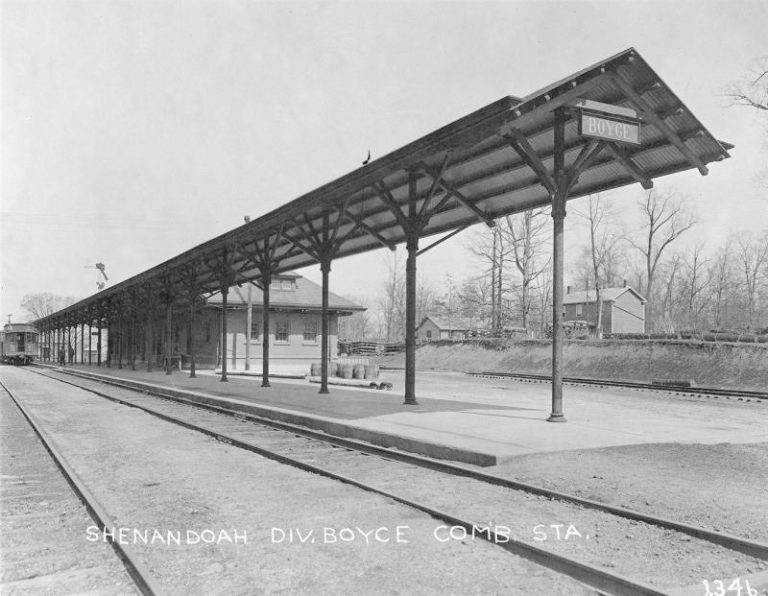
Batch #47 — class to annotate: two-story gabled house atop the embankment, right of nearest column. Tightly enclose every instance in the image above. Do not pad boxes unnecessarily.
[563,286,646,333]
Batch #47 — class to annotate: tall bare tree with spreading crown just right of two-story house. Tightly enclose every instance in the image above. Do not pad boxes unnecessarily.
[629,190,695,331]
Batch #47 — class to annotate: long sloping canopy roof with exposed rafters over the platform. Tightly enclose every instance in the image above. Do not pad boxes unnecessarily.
[40,48,732,322]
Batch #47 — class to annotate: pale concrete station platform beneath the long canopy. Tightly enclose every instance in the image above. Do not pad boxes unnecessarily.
[37,365,768,466]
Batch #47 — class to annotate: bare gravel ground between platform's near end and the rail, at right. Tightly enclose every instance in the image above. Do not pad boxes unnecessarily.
[489,443,768,542]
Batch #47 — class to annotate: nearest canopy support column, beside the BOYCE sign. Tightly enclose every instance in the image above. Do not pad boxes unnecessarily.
[547,109,568,422]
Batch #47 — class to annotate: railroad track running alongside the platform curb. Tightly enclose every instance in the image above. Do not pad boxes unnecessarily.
[18,373,768,595]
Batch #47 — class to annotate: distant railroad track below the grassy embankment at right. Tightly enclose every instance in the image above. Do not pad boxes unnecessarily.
[467,371,768,401]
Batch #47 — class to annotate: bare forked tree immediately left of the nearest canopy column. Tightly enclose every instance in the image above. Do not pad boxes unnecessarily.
[501,209,549,333]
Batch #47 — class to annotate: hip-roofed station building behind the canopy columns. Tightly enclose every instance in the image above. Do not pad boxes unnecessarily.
[201,272,365,374]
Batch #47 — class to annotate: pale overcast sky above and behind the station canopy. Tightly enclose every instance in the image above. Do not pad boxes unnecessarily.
[0,0,768,322]
